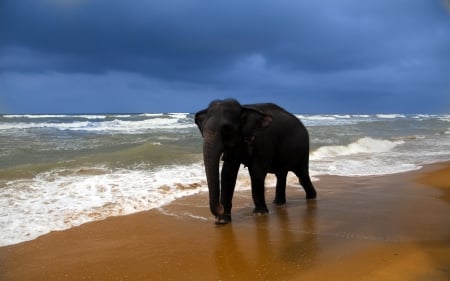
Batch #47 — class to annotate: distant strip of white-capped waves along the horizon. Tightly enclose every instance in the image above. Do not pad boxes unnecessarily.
[0,113,450,132]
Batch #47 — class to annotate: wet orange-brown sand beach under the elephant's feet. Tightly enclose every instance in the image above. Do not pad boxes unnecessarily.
[0,162,450,280]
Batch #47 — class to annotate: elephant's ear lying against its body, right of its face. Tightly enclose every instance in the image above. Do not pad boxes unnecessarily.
[241,106,272,138]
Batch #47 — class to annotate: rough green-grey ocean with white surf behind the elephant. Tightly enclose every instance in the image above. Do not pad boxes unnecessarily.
[0,113,450,246]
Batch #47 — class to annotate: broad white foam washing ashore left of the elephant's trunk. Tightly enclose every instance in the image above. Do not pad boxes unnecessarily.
[0,164,206,246]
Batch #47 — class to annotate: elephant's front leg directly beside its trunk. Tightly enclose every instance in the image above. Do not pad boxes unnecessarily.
[220,160,240,224]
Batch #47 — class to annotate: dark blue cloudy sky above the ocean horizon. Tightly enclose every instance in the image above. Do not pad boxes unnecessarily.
[0,0,450,113]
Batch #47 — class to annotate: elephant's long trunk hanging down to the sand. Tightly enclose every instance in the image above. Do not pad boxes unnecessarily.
[203,130,224,217]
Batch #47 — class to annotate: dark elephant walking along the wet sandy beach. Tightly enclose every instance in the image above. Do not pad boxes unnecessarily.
[195,99,317,224]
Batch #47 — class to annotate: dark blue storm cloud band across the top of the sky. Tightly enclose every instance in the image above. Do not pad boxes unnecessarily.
[1,0,449,76]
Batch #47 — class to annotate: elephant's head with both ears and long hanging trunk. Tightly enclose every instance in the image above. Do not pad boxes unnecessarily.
[195,99,272,217]
